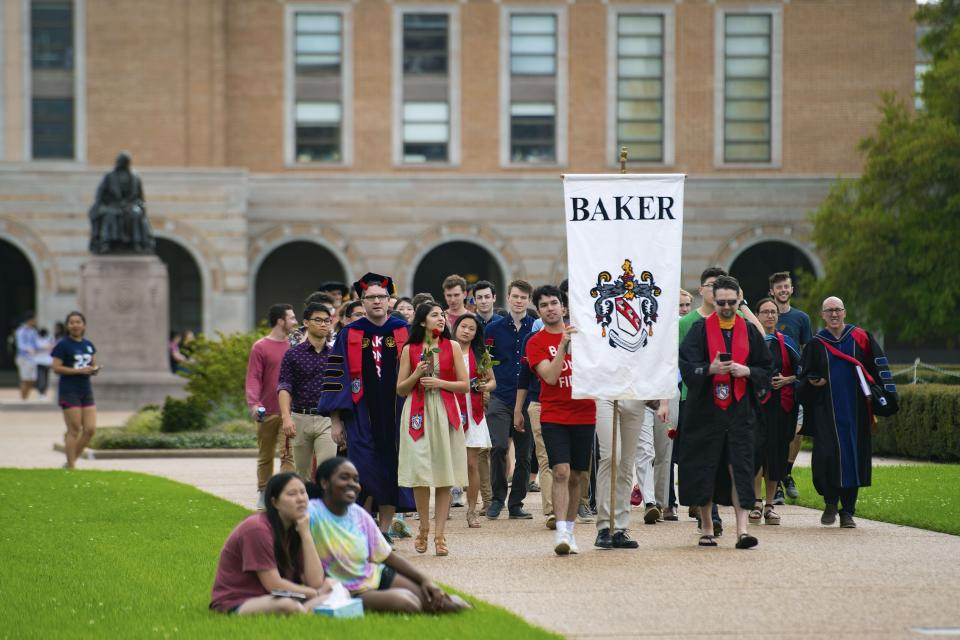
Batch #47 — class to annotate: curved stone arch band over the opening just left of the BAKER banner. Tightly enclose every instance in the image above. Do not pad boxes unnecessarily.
[396,224,524,293]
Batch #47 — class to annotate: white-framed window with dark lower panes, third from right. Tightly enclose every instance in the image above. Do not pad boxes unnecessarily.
[501,10,565,165]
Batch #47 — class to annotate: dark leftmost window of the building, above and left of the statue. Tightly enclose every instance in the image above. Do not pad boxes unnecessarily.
[30,0,76,160]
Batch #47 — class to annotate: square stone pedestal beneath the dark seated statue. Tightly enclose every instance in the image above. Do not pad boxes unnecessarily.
[80,255,186,410]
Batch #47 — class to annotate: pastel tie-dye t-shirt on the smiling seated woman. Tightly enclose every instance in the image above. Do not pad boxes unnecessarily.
[309,500,393,593]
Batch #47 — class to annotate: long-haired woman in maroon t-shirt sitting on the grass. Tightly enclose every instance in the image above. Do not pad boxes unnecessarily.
[210,473,330,615]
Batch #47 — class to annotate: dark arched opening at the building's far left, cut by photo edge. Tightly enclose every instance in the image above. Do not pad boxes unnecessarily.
[0,240,37,385]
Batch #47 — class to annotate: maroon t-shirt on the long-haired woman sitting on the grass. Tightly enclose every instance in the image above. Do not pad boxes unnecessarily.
[210,513,299,611]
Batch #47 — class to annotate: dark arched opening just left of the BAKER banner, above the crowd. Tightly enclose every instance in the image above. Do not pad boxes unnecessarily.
[408,241,506,304]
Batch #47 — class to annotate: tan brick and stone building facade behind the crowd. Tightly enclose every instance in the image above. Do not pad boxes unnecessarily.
[0,0,916,368]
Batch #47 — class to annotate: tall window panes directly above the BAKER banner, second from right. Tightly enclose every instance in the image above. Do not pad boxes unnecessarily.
[616,14,665,162]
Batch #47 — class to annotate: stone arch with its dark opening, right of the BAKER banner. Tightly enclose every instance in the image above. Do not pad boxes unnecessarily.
[711,224,823,301]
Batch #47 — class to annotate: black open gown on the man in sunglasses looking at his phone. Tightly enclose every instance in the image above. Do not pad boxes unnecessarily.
[678,320,773,509]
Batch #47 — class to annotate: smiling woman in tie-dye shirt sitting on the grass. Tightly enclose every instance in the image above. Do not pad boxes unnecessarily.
[310,457,470,613]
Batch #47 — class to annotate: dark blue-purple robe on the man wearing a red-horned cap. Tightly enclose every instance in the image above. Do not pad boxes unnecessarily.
[317,316,416,511]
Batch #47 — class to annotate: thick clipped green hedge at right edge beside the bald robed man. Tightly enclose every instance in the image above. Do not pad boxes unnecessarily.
[873,384,960,462]
